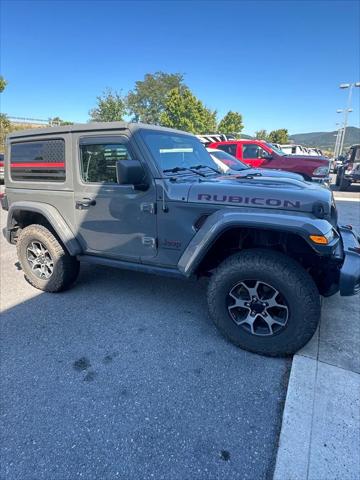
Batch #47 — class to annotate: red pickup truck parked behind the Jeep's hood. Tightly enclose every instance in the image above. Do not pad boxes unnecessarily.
[208,140,330,182]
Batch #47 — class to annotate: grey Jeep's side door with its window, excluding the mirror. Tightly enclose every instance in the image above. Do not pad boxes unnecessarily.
[74,135,156,261]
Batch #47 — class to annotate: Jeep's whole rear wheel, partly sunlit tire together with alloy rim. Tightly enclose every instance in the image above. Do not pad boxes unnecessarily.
[16,225,79,292]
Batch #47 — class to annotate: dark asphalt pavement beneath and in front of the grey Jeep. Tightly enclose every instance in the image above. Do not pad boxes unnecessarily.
[0,198,290,480]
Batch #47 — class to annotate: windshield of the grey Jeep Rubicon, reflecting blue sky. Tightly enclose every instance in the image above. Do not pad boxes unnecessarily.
[141,130,220,173]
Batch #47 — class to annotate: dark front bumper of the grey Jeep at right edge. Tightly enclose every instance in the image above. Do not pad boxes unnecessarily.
[339,227,360,297]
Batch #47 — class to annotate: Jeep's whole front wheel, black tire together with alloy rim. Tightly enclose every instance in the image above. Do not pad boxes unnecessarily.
[208,249,321,356]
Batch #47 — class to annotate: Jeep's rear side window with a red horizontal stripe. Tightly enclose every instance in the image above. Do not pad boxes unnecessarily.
[10,139,65,182]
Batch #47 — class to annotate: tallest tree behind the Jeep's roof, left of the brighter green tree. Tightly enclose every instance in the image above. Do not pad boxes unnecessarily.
[126,72,186,125]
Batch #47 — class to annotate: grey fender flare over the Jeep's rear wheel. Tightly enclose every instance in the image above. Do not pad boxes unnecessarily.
[6,202,82,256]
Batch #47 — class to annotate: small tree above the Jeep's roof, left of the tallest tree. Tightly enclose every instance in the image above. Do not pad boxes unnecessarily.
[89,88,126,122]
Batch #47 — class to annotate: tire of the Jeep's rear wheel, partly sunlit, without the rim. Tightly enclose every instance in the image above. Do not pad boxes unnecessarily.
[16,225,80,292]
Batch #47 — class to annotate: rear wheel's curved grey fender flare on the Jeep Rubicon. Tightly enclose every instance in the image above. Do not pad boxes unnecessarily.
[7,202,82,256]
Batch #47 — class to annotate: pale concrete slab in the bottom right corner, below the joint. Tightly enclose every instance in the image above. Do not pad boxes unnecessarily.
[274,355,360,480]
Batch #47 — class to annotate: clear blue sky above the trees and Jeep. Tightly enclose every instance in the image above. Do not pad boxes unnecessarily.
[1,0,360,134]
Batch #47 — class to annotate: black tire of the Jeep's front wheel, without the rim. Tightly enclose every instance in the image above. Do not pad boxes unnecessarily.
[208,249,321,356]
